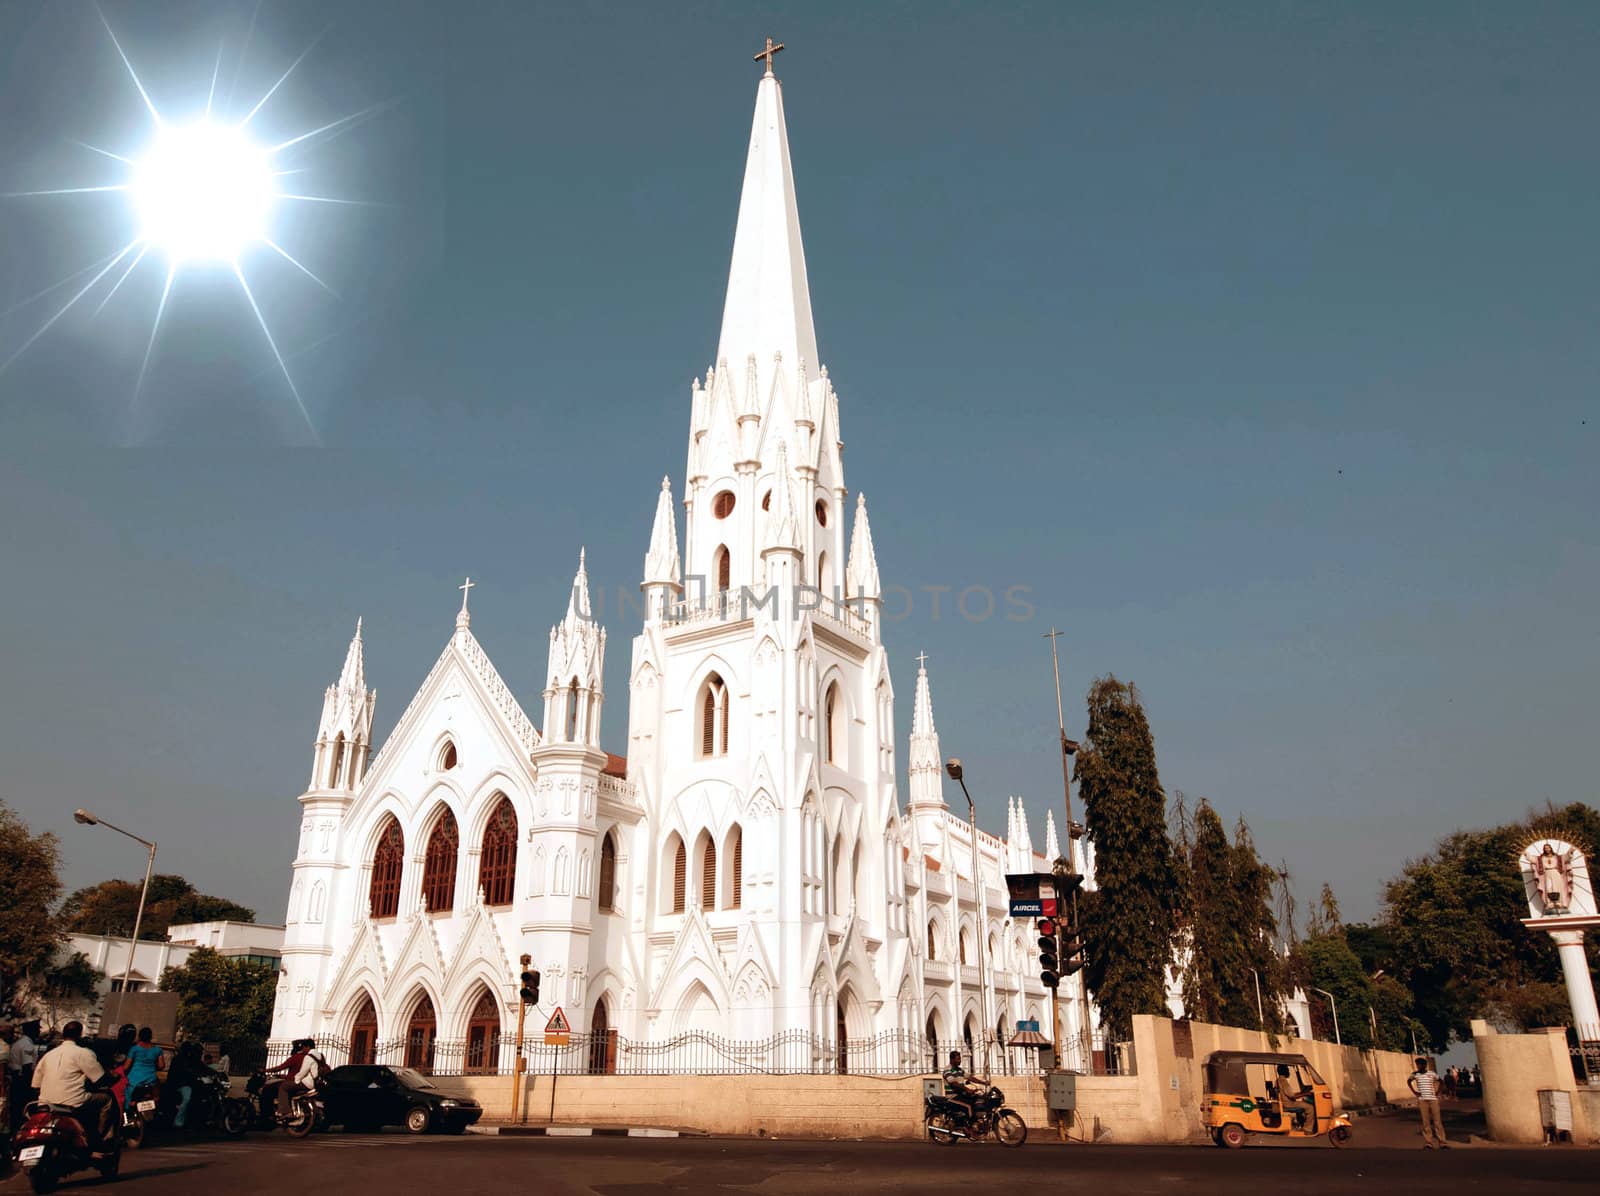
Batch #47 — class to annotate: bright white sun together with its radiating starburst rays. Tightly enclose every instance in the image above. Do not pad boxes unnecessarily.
[0,13,384,443]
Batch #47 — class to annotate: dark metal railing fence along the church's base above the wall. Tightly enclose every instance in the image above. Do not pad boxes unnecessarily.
[262,1030,1133,1076]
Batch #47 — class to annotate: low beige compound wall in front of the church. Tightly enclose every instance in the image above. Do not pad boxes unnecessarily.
[435,1017,1411,1142]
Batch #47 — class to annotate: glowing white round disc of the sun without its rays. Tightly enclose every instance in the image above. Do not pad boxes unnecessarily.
[131,122,277,264]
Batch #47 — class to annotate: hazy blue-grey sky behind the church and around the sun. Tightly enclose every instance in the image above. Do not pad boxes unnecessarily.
[0,0,1600,919]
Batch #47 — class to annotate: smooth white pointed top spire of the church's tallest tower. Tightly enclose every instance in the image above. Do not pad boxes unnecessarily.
[717,64,819,406]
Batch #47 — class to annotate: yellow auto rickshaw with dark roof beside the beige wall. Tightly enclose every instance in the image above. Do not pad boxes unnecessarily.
[1200,1050,1352,1150]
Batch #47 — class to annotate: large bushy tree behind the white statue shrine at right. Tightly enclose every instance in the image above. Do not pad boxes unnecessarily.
[1382,803,1600,1046]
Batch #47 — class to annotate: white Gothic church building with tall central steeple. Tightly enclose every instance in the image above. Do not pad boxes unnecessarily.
[272,59,1078,1071]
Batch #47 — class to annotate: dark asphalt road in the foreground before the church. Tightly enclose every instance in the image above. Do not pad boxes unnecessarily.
[0,1134,1600,1196]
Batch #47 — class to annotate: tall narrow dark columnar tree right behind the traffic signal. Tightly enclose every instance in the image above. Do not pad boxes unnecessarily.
[1077,676,1181,1039]
